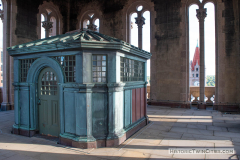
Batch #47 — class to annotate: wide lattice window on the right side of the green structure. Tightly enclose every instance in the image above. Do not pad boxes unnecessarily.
[120,57,144,82]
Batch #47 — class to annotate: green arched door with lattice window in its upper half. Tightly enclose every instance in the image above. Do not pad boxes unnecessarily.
[38,68,60,136]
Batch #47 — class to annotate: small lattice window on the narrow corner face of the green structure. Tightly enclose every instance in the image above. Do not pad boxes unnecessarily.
[92,55,107,83]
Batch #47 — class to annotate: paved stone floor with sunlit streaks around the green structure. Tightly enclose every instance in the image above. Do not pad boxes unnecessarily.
[0,106,240,160]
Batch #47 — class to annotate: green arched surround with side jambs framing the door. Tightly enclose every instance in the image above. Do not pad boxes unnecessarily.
[27,57,65,133]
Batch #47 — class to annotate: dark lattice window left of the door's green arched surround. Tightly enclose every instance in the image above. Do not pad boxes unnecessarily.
[20,58,36,82]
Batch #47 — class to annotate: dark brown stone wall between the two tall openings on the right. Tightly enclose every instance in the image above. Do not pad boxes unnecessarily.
[151,0,186,101]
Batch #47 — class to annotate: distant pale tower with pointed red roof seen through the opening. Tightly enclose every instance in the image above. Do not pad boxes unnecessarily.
[189,42,200,86]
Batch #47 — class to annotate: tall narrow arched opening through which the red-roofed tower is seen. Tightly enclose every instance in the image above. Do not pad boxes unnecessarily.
[188,4,200,102]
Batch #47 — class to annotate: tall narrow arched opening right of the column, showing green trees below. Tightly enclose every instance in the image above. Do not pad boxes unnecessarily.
[204,2,216,87]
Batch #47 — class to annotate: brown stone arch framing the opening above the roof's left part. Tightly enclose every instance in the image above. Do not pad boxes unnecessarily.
[37,1,63,39]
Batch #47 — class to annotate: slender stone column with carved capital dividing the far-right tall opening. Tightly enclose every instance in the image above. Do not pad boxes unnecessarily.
[196,8,207,108]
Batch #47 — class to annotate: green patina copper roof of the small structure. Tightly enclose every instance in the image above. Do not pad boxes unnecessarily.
[7,29,151,58]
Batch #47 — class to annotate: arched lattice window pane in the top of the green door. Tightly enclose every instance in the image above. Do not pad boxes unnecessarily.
[41,72,57,95]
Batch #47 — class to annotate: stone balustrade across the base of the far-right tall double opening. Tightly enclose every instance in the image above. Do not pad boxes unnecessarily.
[190,87,215,105]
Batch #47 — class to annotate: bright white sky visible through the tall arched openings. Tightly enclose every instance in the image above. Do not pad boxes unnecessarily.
[0,1,215,76]
